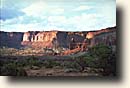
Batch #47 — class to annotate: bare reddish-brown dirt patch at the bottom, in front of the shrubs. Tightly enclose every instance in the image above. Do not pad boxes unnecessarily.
[26,68,99,76]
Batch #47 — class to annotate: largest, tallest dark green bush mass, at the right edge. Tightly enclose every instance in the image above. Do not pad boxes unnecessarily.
[76,44,116,75]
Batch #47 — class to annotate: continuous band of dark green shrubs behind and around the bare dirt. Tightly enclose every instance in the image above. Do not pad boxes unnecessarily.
[0,44,116,76]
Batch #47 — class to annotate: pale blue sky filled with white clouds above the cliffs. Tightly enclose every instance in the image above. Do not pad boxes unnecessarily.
[0,0,116,32]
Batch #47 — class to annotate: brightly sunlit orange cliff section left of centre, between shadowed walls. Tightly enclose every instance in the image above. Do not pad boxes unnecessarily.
[21,31,57,47]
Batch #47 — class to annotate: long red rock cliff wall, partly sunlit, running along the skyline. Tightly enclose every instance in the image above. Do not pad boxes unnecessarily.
[0,27,116,48]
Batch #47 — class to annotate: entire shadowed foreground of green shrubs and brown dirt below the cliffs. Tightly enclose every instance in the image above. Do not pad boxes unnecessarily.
[0,44,116,76]
